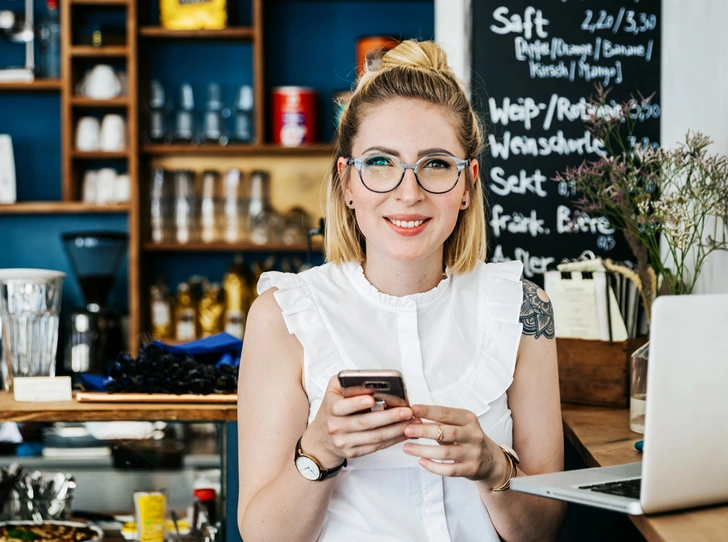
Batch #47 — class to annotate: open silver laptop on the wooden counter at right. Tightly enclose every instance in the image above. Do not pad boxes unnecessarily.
[511,294,728,515]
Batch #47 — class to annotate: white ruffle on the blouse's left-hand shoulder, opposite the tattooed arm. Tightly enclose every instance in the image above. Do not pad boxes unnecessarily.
[258,268,346,390]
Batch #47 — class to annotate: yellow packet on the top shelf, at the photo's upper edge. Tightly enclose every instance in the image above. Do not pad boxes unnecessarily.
[159,0,227,30]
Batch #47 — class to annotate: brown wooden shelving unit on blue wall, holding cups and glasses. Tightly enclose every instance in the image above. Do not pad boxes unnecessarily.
[0,0,334,360]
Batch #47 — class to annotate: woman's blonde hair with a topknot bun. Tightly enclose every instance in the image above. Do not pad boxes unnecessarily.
[324,40,486,273]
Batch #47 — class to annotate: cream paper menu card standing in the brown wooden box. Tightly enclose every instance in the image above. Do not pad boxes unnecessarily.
[544,271,627,341]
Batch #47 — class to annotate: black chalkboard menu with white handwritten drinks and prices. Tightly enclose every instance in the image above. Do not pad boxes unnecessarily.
[471,0,660,283]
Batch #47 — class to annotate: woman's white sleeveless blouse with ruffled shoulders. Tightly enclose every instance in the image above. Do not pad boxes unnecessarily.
[258,262,523,542]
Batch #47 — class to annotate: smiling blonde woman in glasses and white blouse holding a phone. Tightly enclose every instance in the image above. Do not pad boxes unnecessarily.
[238,41,564,542]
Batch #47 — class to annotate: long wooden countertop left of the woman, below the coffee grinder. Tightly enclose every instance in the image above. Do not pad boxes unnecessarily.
[0,392,237,428]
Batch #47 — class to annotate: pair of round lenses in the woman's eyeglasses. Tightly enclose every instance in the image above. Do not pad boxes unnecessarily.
[361,154,459,192]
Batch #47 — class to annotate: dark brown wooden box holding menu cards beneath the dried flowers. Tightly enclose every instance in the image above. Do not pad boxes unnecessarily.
[556,337,648,408]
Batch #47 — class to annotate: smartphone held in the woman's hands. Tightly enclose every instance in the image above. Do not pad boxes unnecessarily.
[339,369,409,411]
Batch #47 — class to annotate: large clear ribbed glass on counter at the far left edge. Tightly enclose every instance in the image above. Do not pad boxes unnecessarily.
[0,269,66,391]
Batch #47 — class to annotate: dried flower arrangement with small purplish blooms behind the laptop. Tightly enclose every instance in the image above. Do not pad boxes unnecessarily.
[555,87,728,318]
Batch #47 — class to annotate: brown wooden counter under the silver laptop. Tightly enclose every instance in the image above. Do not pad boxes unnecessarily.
[561,404,728,542]
